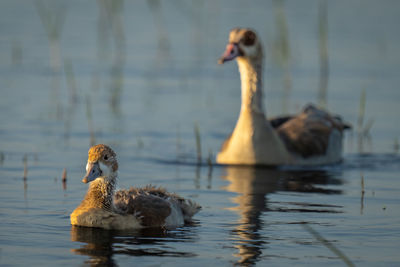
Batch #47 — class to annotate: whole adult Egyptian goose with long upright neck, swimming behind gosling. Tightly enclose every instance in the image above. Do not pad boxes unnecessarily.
[217,28,349,165]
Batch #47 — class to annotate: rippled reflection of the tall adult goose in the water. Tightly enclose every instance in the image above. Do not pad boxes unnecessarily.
[222,166,342,265]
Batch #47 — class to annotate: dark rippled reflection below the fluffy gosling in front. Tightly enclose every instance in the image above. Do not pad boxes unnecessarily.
[71,226,198,266]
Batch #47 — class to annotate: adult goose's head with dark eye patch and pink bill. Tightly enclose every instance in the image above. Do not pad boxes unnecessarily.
[218,28,263,64]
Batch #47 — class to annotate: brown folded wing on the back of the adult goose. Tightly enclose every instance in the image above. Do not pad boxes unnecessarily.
[277,105,348,158]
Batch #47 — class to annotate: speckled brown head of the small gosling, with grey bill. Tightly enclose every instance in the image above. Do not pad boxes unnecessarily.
[82,144,118,183]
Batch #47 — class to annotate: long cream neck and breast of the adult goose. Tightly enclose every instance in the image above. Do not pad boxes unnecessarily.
[217,57,290,165]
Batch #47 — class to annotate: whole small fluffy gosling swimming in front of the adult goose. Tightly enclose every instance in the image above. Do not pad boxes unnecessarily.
[71,145,200,229]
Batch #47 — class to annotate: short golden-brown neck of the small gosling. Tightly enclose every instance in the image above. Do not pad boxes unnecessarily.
[82,174,117,211]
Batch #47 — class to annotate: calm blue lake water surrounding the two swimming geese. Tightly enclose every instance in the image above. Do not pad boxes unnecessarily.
[0,1,400,266]
